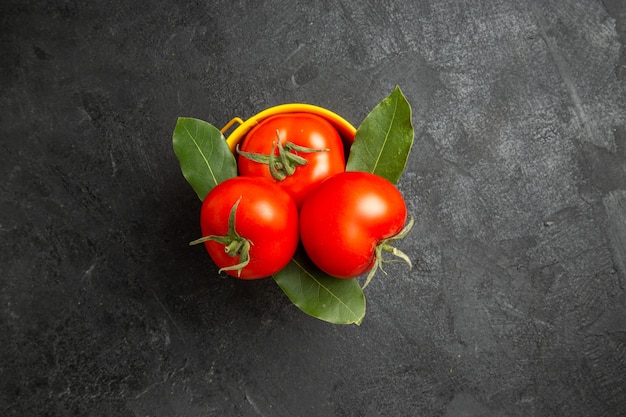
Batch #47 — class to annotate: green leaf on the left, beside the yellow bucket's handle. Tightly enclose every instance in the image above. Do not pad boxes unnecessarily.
[172,117,237,200]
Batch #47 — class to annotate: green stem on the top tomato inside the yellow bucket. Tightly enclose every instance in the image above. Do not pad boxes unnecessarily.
[237,130,328,181]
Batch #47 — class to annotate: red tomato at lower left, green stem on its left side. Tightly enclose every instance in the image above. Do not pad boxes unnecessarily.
[192,177,298,279]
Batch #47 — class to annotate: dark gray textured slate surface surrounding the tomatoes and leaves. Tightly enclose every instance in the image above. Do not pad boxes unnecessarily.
[0,0,626,417]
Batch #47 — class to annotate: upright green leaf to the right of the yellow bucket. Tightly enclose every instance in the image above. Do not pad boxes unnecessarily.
[346,87,414,184]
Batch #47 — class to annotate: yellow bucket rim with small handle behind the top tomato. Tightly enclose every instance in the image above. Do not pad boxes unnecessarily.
[221,103,356,152]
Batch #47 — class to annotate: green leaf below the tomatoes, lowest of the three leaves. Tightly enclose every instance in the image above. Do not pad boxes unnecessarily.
[274,253,365,325]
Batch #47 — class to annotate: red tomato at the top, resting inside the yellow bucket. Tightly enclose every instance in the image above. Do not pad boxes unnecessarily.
[238,113,346,207]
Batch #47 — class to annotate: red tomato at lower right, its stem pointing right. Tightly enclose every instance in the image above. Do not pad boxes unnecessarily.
[300,172,410,278]
